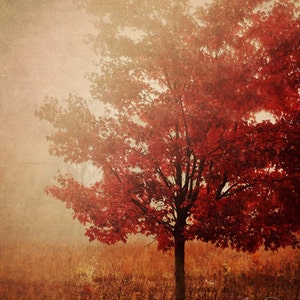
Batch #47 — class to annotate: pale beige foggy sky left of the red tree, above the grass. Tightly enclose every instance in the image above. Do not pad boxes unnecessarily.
[0,0,94,241]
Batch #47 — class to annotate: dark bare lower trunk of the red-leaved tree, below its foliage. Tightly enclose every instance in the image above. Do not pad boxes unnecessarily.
[175,239,185,300]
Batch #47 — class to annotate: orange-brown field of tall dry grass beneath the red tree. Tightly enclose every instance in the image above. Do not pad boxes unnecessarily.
[0,239,300,300]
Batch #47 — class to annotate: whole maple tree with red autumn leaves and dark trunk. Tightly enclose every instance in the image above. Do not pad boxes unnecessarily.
[36,0,300,300]
